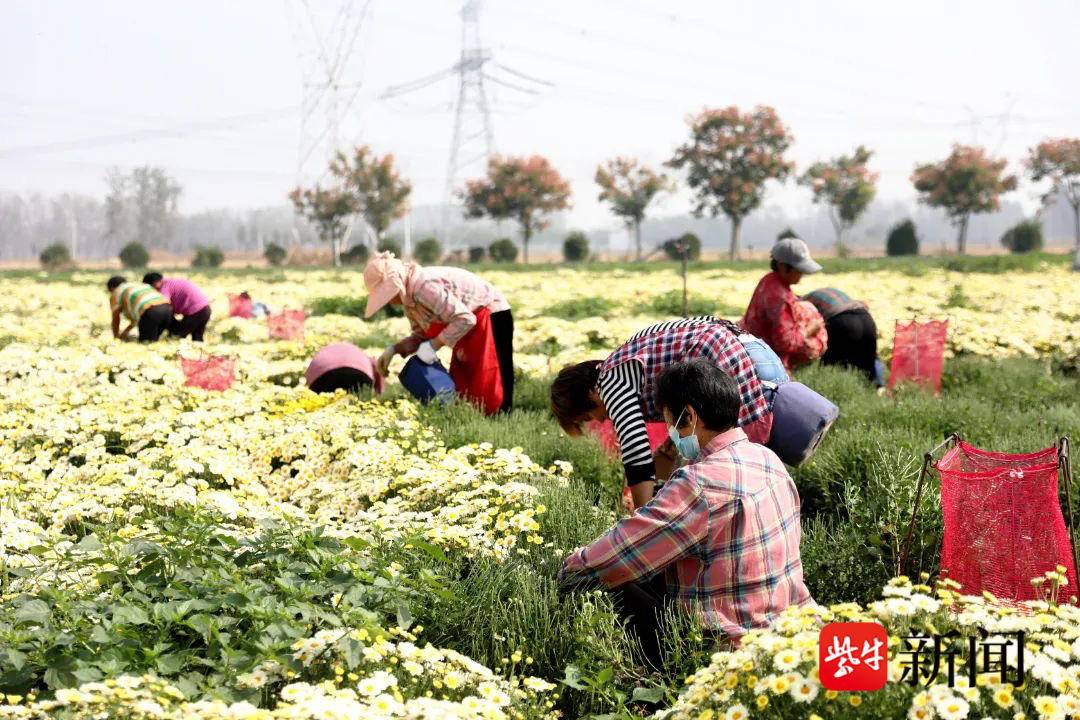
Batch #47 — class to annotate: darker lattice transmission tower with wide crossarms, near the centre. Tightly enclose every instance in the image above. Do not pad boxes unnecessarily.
[379,0,552,247]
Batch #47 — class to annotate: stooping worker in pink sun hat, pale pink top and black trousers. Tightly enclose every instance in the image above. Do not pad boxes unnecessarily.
[364,253,514,412]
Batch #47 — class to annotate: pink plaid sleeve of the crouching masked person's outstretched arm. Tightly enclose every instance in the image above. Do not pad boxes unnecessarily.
[559,467,708,587]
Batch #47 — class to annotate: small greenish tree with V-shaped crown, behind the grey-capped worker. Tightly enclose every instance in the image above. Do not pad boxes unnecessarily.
[799,145,878,255]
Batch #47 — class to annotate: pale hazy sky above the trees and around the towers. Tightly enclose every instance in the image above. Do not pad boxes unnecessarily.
[0,0,1080,226]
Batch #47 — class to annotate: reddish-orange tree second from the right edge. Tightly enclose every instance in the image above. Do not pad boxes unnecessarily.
[912,145,1016,255]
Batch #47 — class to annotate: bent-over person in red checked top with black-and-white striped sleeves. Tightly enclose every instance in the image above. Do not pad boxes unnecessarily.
[551,315,772,507]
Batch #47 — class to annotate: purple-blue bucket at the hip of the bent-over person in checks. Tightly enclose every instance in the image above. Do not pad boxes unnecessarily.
[766,382,840,466]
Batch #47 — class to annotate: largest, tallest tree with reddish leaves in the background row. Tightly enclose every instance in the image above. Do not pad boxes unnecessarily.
[667,106,795,260]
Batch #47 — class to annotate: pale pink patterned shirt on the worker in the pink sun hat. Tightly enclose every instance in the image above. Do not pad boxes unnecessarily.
[403,268,510,352]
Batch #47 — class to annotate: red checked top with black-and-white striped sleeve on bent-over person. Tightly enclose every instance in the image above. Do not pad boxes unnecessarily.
[598,316,769,485]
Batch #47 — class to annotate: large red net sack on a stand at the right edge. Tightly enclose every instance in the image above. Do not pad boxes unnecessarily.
[937,443,1077,600]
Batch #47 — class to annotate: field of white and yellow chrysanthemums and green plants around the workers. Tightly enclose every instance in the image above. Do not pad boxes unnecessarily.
[0,259,1080,720]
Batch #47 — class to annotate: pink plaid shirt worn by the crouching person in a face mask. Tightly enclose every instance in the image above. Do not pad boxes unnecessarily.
[559,427,813,639]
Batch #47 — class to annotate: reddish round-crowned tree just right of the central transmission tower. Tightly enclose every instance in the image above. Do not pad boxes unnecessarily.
[459,155,570,262]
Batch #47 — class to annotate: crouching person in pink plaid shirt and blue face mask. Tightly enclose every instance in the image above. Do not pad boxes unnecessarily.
[558,358,813,660]
